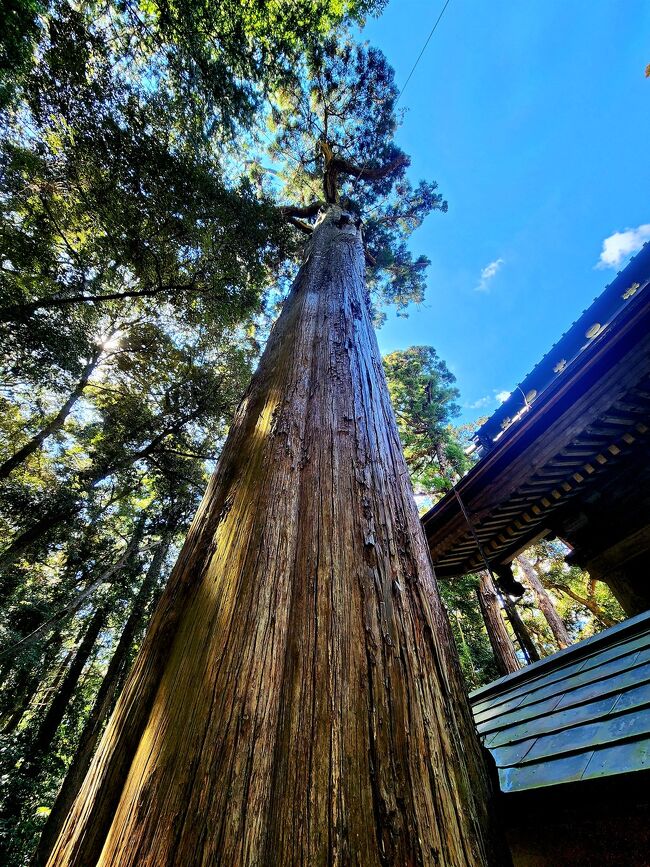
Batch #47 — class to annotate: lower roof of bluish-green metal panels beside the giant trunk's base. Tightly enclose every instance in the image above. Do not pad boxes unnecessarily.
[470,612,650,793]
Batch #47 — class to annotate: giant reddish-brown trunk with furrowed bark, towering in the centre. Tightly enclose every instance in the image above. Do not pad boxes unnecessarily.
[49,207,503,867]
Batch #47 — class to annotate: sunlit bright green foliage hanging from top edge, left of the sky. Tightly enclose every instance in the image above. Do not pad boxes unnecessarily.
[113,0,382,131]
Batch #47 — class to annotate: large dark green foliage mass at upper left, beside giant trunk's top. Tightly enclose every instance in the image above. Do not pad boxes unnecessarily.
[0,5,286,368]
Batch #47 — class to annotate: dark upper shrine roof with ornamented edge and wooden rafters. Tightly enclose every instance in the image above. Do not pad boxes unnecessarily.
[422,244,650,577]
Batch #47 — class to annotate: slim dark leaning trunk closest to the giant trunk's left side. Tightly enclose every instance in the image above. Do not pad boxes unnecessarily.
[31,532,171,867]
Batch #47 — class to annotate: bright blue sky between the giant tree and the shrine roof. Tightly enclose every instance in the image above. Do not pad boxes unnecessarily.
[364,0,650,421]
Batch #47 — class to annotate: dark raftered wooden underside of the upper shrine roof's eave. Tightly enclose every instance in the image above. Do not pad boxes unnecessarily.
[422,247,650,576]
